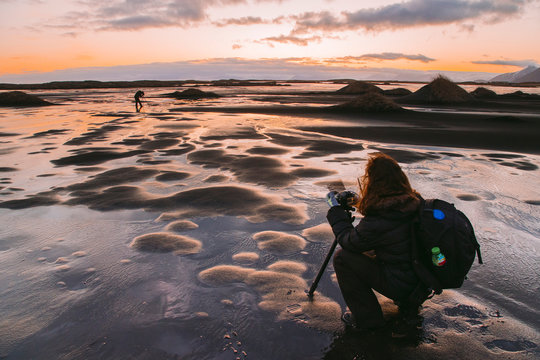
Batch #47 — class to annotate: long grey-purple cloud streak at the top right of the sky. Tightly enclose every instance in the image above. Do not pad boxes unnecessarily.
[293,0,527,34]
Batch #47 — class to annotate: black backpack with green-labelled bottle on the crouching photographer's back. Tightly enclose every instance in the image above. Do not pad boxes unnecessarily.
[411,199,483,303]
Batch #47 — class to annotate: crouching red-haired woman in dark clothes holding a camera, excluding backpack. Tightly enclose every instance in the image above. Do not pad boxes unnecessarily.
[327,153,428,337]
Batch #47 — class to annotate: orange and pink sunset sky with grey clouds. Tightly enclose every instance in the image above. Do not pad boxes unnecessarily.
[0,0,540,83]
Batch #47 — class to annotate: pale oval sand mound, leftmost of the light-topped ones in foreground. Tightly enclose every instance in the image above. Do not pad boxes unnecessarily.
[129,232,202,255]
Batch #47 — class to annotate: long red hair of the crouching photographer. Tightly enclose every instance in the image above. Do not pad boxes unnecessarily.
[358,153,420,215]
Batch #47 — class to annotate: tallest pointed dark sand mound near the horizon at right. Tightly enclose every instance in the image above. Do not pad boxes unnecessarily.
[402,76,474,104]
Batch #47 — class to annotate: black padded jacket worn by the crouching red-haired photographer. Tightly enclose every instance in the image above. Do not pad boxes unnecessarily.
[326,195,420,293]
